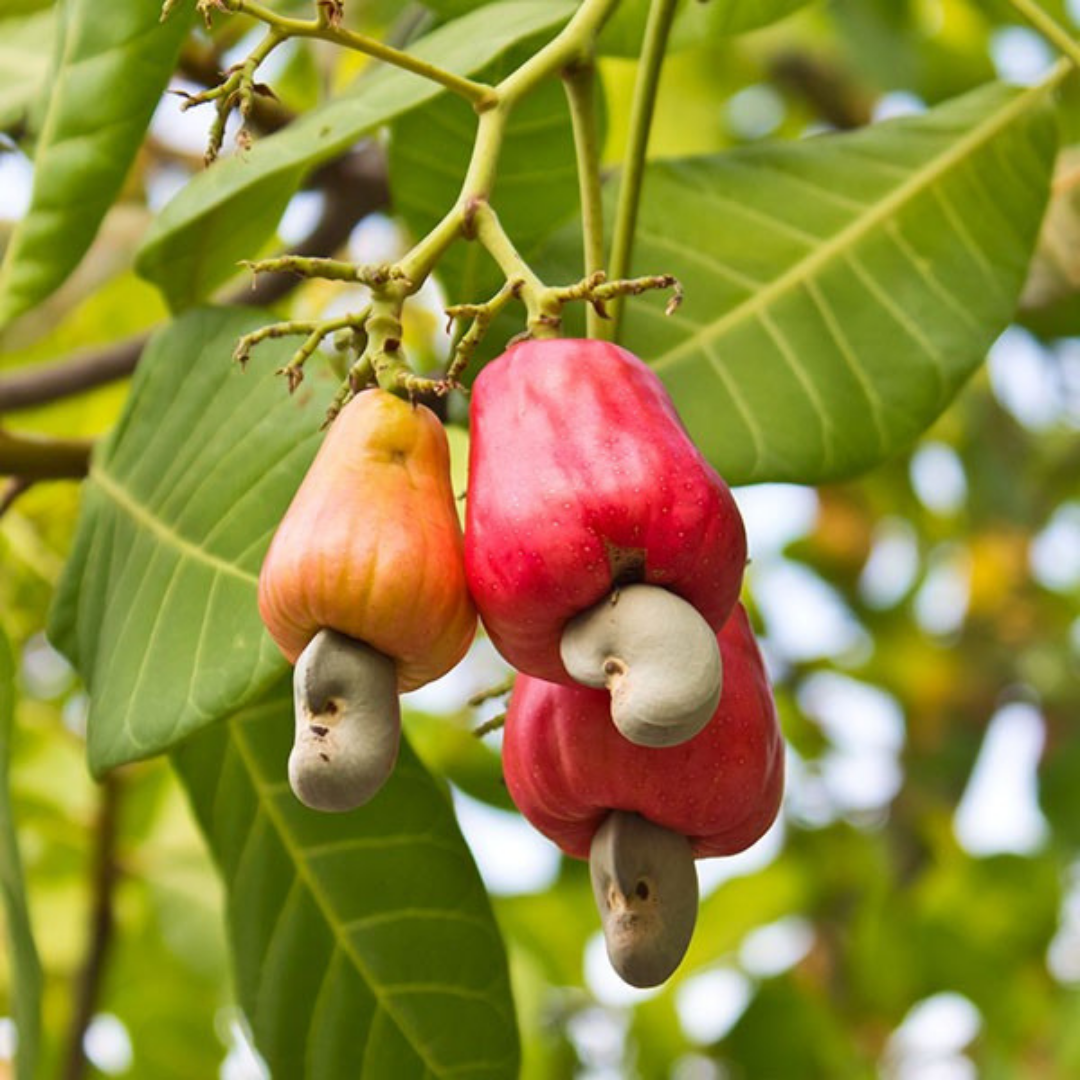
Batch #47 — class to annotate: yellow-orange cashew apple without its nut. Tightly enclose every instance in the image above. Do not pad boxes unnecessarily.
[259,390,476,691]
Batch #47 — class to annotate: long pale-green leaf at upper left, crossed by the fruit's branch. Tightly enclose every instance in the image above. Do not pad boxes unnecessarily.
[137,0,573,307]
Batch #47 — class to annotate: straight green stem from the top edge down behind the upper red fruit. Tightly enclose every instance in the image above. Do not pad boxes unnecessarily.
[605,0,677,340]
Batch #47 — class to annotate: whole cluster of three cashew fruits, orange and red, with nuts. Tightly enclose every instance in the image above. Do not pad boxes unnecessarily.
[259,340,783,986]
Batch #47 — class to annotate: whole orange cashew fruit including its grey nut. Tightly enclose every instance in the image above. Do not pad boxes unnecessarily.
[259,390,476,810]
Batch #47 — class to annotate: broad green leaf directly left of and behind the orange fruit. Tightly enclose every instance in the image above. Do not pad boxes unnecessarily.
[50,309,334,772]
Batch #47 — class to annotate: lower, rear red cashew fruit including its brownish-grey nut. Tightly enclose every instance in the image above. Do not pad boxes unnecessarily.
[502,605,784,986]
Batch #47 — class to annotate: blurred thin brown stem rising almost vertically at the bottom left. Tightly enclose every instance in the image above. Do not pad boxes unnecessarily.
[60,773,122,1080]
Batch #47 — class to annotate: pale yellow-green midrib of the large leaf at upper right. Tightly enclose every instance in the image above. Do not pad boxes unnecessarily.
[651,68,1071,370]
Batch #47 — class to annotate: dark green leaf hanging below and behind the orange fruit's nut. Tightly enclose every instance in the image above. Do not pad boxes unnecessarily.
[174,683,518,1080]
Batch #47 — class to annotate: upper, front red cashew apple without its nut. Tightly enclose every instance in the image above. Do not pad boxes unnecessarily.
[465,339,746,685]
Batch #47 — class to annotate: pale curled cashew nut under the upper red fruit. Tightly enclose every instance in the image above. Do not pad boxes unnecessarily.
[559,584,723,746]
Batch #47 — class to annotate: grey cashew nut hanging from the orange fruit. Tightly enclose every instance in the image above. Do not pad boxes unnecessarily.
[288,630,402,811]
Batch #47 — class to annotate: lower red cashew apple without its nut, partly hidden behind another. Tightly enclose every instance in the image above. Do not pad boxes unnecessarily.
[502,605,784,859]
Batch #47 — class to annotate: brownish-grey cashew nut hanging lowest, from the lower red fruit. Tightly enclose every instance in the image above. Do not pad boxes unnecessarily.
[589,810,698,986]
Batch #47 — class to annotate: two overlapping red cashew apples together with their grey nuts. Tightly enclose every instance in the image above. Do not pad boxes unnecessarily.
[465,341,783,986]
